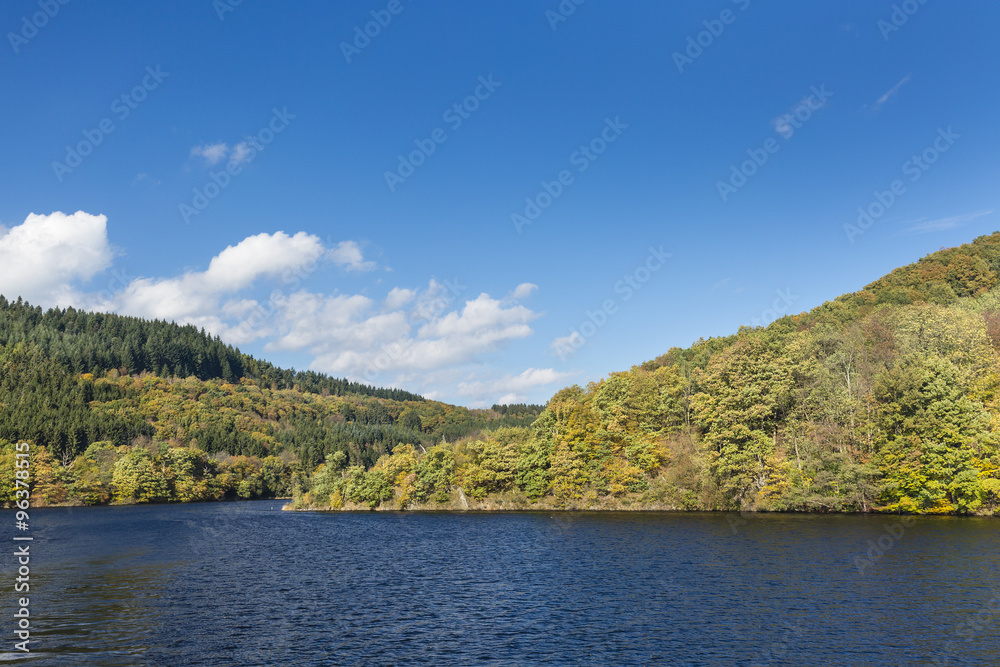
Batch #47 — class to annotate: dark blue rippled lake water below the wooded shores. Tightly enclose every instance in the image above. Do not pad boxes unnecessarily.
[0,501,1000,666]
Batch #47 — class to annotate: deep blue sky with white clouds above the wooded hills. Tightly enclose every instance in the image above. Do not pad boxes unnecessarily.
[0,0,1000,407]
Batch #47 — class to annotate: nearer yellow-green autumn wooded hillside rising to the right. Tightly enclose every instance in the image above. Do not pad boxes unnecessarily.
[296,233,1000,513]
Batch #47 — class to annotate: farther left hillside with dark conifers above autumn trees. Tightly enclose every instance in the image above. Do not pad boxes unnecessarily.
[0,297,542,504]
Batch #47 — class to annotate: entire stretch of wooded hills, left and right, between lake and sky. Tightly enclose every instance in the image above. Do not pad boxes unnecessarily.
[0,233,1000,513]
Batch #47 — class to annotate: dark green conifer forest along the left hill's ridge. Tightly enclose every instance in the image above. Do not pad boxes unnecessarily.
[0,295,423,401]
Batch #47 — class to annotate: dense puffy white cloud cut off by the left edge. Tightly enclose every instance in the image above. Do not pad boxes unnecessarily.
[0,211,114,306]
